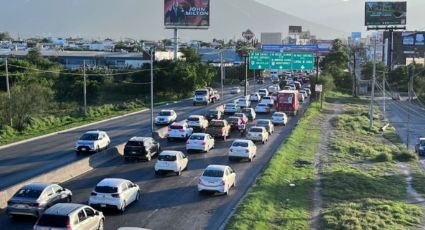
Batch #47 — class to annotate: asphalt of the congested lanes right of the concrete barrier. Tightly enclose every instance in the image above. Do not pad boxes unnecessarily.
[0,88,306,230]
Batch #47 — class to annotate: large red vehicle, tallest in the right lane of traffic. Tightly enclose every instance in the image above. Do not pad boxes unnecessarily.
[275,90,299,116]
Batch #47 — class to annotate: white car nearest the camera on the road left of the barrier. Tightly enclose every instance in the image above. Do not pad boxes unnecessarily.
[74,130,111,154]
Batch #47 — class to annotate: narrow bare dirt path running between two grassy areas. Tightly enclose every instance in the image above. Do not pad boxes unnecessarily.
[310,103,342,229]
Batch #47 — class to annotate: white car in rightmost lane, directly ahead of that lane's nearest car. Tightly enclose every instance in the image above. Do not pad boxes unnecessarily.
[229,139,257,162]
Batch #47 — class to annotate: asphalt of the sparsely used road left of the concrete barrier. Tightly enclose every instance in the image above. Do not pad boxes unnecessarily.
[0,85,266,190]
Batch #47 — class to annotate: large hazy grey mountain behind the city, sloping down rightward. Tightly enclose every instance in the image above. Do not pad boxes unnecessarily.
[0,0,346,41]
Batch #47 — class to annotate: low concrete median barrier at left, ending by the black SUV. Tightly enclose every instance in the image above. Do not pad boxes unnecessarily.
[0,144,124,209]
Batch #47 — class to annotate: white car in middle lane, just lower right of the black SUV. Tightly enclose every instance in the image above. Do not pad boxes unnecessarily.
[154,150,189,176]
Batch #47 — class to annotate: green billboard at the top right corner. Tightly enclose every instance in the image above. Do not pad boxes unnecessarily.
[365,2,407,26]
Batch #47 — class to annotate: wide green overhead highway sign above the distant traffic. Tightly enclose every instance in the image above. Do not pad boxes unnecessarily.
[249,52,314,70]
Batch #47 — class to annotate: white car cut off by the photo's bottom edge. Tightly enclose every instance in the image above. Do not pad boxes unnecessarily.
[33,203,105,230]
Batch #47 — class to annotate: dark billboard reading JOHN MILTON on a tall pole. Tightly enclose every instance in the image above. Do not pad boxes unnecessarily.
[164,0,210,29]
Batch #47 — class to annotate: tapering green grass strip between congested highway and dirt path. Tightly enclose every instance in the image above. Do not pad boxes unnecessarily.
[227,101,320,229]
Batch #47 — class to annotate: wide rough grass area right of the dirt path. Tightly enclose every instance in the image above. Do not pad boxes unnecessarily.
[321,95,423,229]
